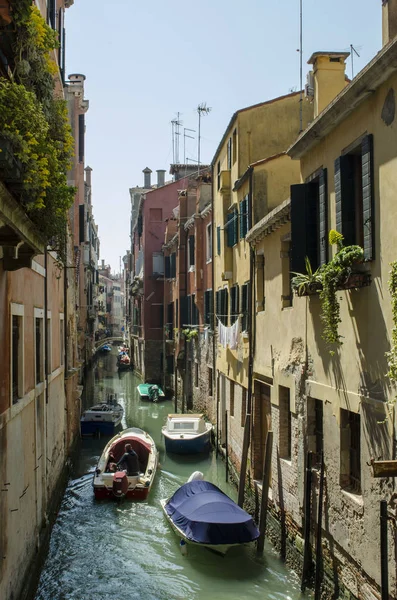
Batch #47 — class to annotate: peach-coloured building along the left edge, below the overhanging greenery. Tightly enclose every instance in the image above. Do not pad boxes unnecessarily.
[0,0,81,600]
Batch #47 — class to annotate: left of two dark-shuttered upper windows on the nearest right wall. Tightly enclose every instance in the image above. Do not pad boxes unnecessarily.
[290,169,328,273]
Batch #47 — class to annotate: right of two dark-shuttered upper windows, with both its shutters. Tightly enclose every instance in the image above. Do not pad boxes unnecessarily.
[335,135,374,260]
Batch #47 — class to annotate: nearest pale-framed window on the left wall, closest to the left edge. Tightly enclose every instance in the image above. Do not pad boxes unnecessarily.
[10,304,24,404]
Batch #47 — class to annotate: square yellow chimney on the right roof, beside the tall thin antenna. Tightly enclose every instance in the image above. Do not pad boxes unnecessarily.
[308,51,348,118]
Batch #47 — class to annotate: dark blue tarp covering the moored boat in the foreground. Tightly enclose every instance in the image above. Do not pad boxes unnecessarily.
[165,481,259,545]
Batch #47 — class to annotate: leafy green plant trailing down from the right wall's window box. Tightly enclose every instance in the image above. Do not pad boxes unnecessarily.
[320,230,364,353]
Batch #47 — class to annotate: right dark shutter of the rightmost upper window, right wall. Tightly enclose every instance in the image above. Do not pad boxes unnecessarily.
[361,134,375,260]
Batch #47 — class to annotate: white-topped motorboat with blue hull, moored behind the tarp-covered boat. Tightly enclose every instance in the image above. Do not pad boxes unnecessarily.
[161,414,213,454]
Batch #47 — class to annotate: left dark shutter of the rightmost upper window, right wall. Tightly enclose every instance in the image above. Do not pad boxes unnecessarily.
[335,154,356,246]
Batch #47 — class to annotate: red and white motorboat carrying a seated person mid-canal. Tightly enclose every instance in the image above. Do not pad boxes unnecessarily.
[93,427,159,500]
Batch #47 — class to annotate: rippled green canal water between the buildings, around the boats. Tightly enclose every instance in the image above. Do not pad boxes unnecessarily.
[35,349,301,600]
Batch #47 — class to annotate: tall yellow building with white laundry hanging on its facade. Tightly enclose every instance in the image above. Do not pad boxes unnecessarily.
[212,93,313,472]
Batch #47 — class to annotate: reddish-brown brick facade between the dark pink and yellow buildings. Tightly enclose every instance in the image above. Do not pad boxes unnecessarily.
[163,168,216,420]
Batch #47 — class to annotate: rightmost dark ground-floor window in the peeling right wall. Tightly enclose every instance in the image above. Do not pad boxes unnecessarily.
[340,408,361,494]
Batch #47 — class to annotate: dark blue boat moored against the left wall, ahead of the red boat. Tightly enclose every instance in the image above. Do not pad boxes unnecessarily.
[80,396,124,435]
